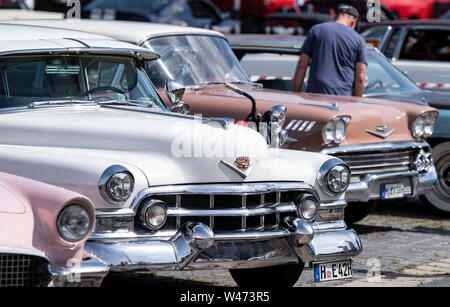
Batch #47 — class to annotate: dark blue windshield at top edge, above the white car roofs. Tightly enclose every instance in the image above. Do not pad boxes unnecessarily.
[84,0,171,14]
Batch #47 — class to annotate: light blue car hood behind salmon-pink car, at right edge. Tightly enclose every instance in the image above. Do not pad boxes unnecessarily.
[372,90,450,110]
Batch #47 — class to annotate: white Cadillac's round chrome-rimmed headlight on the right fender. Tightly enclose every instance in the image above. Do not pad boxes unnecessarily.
[318,158,351,196]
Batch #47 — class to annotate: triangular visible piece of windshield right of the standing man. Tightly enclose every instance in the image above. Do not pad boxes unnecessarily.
[364,50,420,95]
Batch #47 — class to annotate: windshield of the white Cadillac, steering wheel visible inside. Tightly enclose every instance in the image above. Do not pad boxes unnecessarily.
[0,55,165,108]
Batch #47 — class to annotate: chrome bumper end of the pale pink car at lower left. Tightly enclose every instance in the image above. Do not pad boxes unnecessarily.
[48,256,109,287]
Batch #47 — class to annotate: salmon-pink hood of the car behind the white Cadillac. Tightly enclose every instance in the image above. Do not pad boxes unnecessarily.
[184,86,434,151]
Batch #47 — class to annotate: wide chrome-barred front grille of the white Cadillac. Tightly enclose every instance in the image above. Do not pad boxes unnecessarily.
[138,182,315,233]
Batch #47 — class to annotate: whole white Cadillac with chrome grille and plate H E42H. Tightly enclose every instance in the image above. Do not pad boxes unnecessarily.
[0,24,362,286]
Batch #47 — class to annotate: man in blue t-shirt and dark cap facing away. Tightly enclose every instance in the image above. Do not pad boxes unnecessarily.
[294,5,367,97]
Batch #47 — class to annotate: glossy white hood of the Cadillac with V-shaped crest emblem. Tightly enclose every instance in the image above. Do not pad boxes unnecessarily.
[0,106,330,188]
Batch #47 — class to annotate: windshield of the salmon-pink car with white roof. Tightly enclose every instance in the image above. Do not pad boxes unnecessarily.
[146,35,250,88]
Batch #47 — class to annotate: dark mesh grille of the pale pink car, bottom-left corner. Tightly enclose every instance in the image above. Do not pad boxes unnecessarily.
[0,253,48,287]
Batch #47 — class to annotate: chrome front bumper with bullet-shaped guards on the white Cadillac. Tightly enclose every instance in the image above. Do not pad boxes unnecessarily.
[85,217,362,271]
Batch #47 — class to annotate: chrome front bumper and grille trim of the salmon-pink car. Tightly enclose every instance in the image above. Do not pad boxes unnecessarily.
[321,142,437,202]
